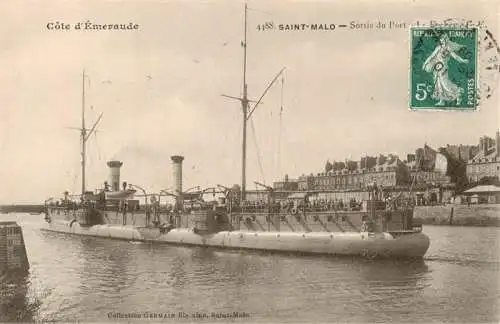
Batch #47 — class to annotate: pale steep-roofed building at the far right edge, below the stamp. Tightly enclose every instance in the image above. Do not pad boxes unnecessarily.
[466,131,500,183]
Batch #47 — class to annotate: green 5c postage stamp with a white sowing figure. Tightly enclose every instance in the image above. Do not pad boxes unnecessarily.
[409,27,478,110]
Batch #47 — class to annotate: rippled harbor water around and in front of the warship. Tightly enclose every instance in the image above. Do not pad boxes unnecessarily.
[0,214,500,323]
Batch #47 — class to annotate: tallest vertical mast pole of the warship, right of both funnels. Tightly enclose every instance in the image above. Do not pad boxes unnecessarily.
[241,3,248,201]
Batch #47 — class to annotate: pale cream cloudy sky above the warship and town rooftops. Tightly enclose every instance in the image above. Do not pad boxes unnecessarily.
[0,0,500,204]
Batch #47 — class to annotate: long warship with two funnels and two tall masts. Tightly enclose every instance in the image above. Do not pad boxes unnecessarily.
[43,5,430,258]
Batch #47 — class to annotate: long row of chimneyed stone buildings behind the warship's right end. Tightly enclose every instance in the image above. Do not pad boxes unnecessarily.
[273,145,460,203]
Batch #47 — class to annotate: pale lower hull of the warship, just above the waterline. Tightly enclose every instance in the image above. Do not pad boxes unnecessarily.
[44,220,430,258]
